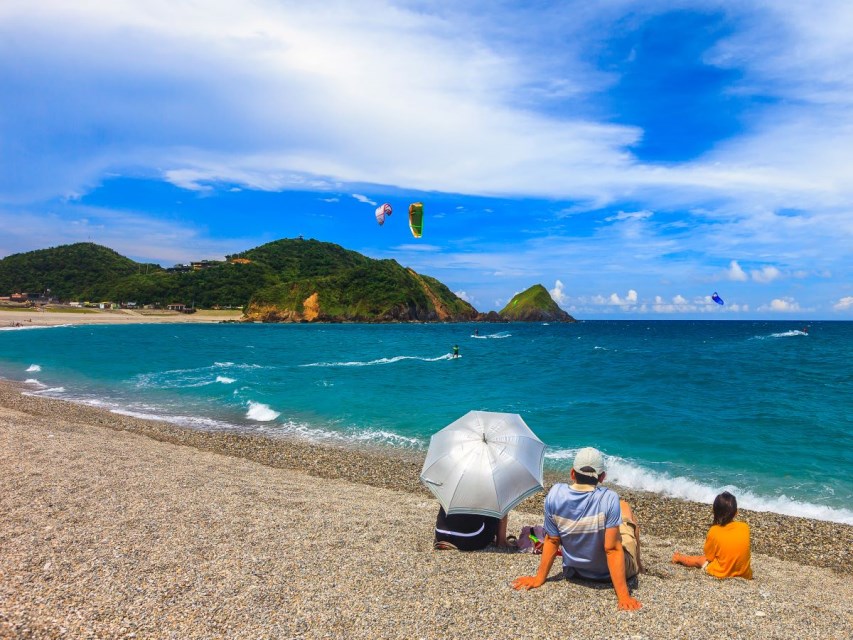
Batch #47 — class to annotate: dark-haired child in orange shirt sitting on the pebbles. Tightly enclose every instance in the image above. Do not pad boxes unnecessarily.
[672,491,752,580]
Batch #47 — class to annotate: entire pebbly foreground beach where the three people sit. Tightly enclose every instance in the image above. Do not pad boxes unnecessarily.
[0,382,853,638]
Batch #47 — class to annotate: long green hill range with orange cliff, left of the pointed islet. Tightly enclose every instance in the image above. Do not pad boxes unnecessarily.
[0,239,477,322]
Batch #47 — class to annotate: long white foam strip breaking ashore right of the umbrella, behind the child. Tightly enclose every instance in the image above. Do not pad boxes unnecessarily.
[545,449,853,524]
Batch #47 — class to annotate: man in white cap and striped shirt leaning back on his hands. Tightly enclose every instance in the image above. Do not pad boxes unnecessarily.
[512,447,642,609]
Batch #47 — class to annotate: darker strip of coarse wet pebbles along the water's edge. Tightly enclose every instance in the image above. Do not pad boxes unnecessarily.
[0,378,853,575]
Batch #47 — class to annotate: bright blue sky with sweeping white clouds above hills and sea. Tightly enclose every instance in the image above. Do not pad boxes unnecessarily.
[0,0,853,321]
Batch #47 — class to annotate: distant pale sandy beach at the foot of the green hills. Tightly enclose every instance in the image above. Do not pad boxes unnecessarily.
[0,307,243,329]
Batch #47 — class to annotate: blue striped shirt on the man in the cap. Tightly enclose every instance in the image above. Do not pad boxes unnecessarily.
[545,483,622,580]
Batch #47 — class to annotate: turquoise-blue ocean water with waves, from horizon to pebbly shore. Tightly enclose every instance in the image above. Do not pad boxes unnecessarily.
[0,321,853,524]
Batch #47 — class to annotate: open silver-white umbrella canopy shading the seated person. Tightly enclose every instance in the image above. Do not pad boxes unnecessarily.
[420,411,545,518]
